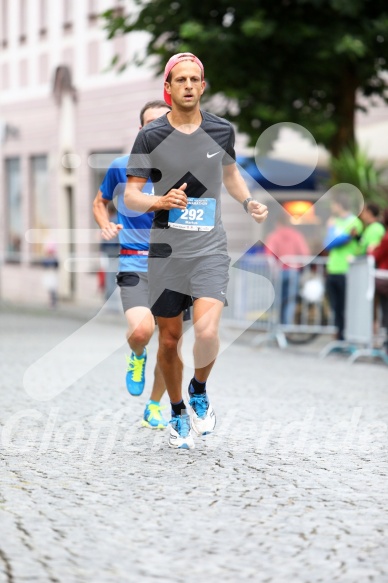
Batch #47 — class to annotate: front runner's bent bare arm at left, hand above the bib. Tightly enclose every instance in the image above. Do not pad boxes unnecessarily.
[124,176,187,213]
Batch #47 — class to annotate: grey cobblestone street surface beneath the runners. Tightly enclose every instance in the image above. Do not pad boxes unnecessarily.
[0,310,388,583]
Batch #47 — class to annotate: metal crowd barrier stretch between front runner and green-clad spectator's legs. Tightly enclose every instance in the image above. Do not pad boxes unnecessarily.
[226,254,335,347]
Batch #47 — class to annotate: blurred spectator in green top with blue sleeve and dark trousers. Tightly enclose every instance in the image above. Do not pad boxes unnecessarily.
[324,193,363,340]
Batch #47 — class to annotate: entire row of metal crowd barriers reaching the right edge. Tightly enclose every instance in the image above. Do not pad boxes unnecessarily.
[223,254,388,364]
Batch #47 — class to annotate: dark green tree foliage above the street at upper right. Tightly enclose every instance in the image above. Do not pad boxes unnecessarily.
[103,0,388,155]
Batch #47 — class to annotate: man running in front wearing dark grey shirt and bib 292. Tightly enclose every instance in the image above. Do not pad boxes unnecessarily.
[125,53,268,449]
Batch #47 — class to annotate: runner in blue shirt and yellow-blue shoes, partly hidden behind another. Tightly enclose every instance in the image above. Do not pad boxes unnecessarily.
[93,100,171,429]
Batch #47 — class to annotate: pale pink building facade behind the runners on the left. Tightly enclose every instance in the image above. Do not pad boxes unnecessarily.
[0,0,170,303]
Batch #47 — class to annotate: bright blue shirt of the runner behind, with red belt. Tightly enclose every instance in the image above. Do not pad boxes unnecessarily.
[100,155,154,271]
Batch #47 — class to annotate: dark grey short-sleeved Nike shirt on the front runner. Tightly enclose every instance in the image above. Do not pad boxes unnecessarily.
[127,111,236,258]
